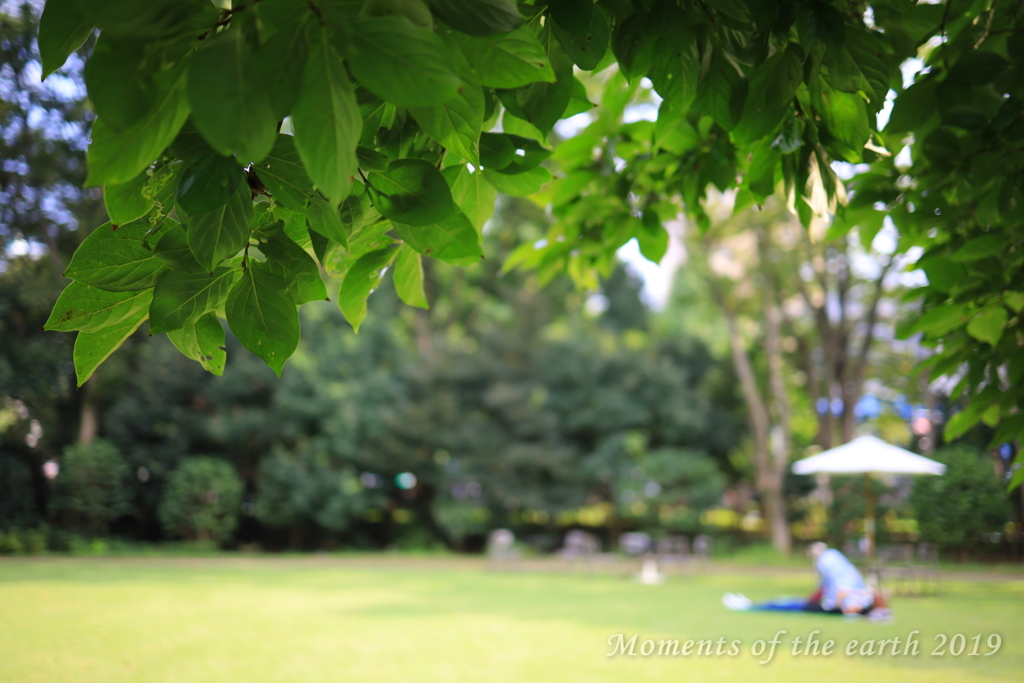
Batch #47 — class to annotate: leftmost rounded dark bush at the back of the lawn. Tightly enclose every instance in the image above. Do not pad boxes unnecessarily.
[51,439,130,536]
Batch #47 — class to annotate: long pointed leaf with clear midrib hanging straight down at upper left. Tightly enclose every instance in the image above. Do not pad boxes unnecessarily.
[292,32,364,202]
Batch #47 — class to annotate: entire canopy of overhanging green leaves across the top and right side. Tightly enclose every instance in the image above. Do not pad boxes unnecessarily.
[32,0,1024,485]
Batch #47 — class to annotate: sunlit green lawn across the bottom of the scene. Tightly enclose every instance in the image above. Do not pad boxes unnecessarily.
[0,557,1024,683]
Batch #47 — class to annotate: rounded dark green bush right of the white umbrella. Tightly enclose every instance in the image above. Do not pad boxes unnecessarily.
[910,446,1011,553]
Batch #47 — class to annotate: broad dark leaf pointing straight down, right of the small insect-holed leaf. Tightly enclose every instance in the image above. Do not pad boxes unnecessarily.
[225,261,299,377]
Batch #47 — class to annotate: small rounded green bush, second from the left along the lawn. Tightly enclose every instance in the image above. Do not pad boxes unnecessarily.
[159,458,242,542]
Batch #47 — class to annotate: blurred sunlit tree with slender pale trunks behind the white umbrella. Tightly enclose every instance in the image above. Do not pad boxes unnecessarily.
[689,198,913,552]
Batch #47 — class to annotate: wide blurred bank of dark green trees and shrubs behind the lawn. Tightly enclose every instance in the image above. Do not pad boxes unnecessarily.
[75,207,737,548]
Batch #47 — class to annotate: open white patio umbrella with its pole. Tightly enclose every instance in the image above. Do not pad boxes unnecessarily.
[792,436,946,555]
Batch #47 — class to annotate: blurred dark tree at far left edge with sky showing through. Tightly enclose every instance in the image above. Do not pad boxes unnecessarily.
[0,0,103,514]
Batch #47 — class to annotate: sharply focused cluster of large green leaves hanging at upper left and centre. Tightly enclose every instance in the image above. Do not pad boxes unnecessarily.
[39,0,569,383]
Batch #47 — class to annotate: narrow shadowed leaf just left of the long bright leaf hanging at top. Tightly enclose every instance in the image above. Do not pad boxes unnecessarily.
[256,11,313,120]
